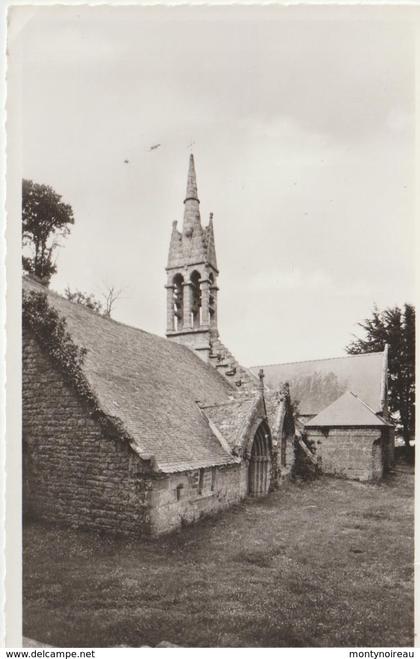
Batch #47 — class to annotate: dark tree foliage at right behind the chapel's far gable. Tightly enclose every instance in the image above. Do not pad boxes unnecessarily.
[346,304,416,446]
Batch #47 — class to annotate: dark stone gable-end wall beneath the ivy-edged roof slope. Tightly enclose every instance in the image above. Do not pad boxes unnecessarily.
[23,332,151,535]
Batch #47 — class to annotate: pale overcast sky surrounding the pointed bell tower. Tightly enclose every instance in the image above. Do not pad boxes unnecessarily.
[9,6,419,365]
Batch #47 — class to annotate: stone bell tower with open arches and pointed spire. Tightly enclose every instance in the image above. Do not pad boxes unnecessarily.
[166,154,219,362]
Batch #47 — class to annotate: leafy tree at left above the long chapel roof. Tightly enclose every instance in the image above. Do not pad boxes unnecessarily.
[22,179,74,284]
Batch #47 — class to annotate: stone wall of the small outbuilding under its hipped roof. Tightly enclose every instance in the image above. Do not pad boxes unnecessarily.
[306,428,384,481]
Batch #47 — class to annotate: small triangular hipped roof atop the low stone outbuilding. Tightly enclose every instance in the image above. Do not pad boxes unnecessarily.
[305,391,389,428]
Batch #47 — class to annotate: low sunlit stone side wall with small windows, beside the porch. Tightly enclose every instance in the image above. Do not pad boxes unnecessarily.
[151,464,241,535]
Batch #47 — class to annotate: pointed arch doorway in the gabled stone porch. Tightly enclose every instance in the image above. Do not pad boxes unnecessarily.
[248,421,272,497]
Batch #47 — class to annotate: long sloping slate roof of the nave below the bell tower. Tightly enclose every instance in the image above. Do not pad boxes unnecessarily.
[23,279,240,473]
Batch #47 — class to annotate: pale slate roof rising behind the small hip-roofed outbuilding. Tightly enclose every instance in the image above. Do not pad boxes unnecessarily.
[251,352,385,416]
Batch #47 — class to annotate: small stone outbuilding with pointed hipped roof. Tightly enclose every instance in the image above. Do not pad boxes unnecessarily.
[305,391,393,481]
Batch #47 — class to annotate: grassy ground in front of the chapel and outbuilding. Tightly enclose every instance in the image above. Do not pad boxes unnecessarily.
[24,467,414,647]
